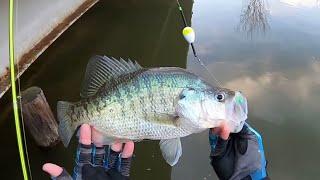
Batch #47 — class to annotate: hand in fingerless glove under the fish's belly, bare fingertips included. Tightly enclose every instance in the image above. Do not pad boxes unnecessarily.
[42,124,134,180]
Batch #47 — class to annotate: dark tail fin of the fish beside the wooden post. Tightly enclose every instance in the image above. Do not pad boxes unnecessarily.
[57,101,77,147]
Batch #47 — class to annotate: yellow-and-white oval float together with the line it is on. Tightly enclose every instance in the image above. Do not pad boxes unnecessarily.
[177,0,221,87]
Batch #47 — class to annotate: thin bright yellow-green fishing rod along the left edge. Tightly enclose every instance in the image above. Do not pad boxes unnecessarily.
[9,0,28,180]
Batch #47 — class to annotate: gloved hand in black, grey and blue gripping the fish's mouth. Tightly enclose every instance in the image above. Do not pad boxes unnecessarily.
[209,121,267,180]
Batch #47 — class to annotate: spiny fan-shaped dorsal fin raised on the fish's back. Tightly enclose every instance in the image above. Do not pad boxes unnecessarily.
[80,55,142,98]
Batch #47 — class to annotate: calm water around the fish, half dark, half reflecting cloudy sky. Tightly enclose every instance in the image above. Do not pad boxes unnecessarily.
[0,0,320,180]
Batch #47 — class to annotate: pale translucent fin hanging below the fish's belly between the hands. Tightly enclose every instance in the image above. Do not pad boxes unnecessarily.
[159,138,182,166]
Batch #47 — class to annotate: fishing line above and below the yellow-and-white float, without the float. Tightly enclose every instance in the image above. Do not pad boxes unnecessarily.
[177,0,221,87]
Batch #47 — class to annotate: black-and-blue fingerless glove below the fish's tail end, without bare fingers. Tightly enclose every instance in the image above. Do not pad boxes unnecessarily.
[52,144,132,180]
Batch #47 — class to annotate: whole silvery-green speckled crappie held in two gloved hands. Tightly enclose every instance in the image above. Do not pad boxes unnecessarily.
[57,56,248,166]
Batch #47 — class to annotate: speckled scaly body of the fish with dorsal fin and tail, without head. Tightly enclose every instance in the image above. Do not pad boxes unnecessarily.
[58,56,208,147]
